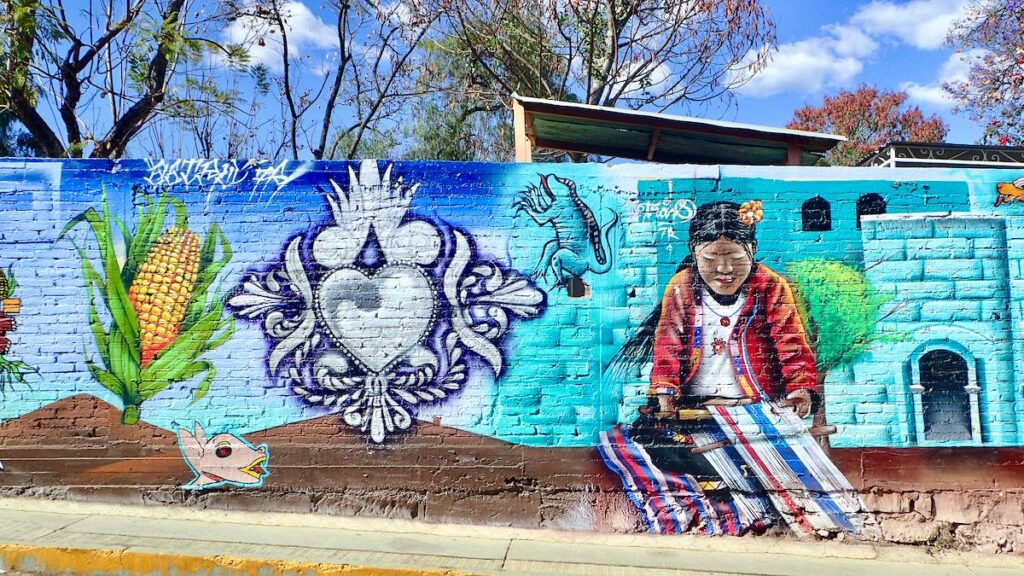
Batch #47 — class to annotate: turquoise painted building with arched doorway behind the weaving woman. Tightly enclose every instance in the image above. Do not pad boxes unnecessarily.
[621,168,1024,447]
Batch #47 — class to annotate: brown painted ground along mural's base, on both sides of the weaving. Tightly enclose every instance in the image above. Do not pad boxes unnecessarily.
[6,395,1024,549]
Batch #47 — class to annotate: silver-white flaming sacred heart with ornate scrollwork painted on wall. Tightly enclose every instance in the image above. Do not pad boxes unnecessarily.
[228,161,545,444]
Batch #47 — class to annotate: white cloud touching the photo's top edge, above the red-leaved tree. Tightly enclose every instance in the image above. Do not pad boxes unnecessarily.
[850,0,971,50]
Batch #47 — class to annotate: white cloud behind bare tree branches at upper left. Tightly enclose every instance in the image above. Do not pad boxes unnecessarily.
[224,0,338,72]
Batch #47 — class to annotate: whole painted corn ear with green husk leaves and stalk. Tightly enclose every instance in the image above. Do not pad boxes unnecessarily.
[57,194,234,424]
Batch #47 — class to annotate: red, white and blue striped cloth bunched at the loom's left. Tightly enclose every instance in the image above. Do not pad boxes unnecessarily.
[598,426,757,536]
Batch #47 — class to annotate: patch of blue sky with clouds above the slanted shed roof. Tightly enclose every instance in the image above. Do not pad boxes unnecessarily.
[726,0,982,143]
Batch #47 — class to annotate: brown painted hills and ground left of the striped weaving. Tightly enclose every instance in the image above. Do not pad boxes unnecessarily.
[0,395,639,529]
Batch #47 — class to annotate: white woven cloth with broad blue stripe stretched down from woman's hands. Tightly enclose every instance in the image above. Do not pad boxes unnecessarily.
[709,401,873,535]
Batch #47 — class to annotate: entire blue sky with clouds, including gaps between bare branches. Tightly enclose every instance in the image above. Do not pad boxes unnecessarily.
[34,0,982,158]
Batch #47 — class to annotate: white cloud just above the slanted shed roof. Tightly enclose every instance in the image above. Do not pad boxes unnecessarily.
[733,26,879,97]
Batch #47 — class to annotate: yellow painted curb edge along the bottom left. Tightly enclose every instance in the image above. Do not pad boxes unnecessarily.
[0,544,472,576]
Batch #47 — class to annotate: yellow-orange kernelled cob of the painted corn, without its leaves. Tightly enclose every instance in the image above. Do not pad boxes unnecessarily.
[128,227,200,366]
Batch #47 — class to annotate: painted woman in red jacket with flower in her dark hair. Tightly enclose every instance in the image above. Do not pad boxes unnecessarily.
[650,201,817,416]
